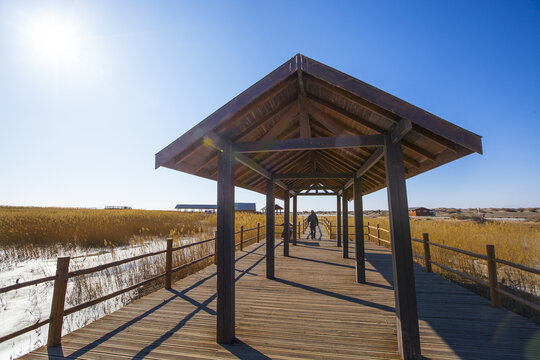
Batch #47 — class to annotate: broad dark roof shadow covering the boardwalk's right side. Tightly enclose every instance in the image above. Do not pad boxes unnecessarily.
[366,248,540,360]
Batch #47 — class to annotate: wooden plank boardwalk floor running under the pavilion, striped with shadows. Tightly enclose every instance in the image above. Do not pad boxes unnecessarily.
[23,233,540,359]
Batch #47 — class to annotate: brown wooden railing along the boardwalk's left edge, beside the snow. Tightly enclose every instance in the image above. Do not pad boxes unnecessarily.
[0,224,266,346]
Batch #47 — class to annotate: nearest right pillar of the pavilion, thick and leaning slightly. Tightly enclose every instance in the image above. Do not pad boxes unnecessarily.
[384,134,421,359]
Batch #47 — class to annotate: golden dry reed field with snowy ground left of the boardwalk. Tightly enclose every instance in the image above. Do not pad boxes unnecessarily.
[0,207,270,358]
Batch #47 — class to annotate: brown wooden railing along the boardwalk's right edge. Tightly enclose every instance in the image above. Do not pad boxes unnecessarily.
[322,218,540,312]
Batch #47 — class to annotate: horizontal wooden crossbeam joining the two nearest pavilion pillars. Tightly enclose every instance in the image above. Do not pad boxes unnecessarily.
[234,135,384,153]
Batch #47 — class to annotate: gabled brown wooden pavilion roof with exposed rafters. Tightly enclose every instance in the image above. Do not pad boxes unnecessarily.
[156,54,482,198]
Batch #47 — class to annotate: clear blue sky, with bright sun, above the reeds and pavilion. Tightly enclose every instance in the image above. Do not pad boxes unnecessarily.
[0,0,540,209]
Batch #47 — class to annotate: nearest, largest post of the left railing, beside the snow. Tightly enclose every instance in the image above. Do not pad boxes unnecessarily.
[47,256,69,347]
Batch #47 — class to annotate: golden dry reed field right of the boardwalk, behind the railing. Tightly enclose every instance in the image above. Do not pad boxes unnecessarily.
[327,216,540,321]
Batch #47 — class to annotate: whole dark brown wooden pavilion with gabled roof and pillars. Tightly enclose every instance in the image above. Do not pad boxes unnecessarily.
[156,54,482,359]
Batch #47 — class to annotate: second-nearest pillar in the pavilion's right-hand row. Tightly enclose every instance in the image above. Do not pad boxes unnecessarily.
[353,176,366,283]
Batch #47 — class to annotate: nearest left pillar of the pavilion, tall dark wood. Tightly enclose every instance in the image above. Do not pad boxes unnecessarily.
[216,143,235,344]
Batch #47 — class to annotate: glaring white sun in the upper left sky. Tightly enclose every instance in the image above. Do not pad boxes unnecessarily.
[23,14,82,66]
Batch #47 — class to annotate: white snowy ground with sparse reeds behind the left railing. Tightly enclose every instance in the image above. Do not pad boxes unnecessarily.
[0,238,211,359]
